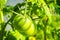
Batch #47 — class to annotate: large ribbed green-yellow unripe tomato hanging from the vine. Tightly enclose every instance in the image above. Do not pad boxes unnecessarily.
[13,14,36,35]
